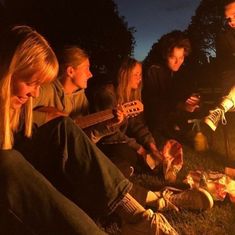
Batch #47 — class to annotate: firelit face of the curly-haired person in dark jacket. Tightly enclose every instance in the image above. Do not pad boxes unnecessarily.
[167,47,185,72]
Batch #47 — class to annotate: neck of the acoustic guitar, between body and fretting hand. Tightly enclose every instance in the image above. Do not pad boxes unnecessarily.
[75,109,114,129]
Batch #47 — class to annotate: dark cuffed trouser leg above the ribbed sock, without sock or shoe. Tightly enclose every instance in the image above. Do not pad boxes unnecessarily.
[15,117,132,220]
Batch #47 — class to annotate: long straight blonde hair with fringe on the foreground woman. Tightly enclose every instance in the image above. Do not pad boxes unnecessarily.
[0,25,58,149]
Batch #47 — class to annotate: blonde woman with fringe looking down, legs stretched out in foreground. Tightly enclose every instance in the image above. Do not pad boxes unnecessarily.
[0,26,180,235]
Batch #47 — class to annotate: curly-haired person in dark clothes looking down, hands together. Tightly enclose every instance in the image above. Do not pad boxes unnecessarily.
[142,30,200,143]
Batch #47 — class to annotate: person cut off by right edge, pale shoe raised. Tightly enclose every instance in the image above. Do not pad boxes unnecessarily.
[204,0,235,178]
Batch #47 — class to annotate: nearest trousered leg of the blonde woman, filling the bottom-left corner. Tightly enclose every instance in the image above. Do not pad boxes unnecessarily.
[0,150,105,235]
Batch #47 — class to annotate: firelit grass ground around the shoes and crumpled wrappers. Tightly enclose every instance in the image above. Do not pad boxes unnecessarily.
[100,131,235,235]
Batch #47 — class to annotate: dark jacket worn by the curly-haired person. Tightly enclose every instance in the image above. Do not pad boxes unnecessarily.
[142,65,192,129]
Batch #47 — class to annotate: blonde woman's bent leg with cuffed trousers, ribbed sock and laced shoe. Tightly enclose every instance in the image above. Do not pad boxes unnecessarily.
[14,118,180,235]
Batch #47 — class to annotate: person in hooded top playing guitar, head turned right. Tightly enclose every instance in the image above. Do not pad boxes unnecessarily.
[33,45,123,142]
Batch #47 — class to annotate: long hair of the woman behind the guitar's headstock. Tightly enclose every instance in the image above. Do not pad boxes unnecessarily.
[117,58,142,104]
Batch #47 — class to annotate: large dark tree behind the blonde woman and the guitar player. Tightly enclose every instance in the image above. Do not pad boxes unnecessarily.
[5,0,135,78]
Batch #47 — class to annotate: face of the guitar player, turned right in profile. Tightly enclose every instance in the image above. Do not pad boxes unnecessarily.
[70,59,92,89]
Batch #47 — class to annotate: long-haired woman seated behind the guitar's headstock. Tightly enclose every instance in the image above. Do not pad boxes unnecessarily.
[90,58,167,176]
